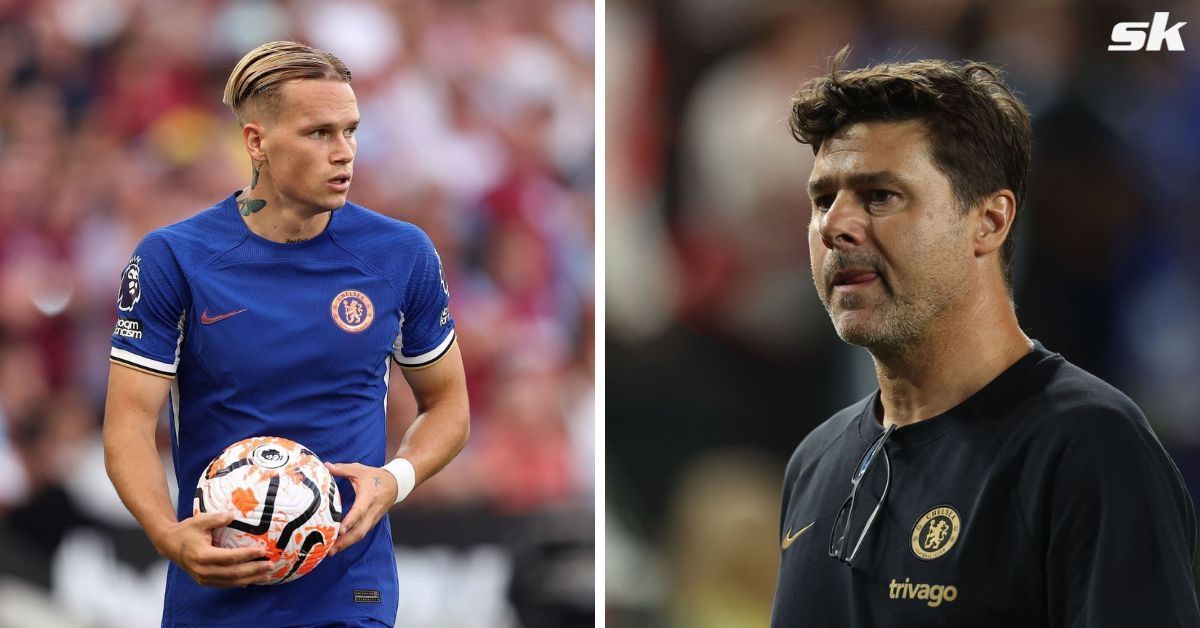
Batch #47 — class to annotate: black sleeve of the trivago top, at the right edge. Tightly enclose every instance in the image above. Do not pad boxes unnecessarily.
[1045,408,1200,627]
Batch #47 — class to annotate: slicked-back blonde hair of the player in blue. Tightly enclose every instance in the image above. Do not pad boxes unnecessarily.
[221,41,350,124]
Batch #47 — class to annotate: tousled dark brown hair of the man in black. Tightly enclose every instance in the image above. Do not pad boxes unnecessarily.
[788,46,1030,293]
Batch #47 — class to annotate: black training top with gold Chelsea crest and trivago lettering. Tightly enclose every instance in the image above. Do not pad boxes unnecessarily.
[772,343,1200,628]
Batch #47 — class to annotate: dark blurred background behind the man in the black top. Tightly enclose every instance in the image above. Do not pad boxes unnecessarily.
[604,0,1200,628]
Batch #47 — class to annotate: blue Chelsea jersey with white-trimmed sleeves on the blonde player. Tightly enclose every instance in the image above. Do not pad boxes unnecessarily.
[110,195,455,627]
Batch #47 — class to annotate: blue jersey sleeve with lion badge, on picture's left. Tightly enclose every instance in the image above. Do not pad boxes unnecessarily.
[109,232,188,377]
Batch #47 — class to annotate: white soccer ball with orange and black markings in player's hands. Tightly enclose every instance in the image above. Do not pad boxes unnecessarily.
[192,436,342,585]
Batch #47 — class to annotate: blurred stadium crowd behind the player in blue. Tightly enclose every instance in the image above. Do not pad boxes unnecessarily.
[0,0,595,627]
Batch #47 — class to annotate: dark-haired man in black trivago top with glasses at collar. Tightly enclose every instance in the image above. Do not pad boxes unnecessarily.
[772,50,1200,628]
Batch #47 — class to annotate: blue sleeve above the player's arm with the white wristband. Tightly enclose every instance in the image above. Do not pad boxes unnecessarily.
[392,233,455,369]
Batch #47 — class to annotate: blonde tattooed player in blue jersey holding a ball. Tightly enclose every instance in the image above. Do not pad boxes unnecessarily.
[104,42,469,627]
